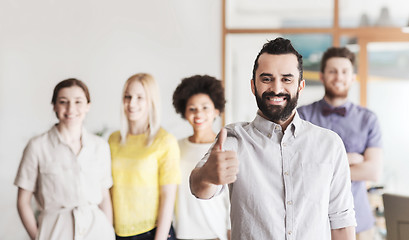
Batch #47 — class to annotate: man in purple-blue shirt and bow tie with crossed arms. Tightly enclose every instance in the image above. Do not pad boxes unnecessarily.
[298,47,382,240]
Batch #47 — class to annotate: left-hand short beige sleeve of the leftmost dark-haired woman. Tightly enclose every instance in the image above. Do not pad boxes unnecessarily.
[14,140,39,192]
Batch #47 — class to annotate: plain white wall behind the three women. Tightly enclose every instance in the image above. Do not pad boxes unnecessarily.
[0,0,221,240]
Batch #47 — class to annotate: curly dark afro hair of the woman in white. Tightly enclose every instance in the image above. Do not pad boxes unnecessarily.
[173,75,226,118]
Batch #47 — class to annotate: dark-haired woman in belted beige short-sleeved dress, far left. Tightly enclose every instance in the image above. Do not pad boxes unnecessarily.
[14,78,115,240]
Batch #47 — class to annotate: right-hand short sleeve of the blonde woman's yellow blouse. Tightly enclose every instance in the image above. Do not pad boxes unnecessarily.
[158,134,181,185]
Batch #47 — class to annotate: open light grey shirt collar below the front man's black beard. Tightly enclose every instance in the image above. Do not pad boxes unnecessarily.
[253,111,301,138]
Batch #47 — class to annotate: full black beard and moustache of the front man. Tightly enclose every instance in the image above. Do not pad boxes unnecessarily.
[254,86,299,122]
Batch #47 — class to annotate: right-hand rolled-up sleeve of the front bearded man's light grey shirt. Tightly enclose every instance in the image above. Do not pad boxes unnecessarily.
[328,137,356,229]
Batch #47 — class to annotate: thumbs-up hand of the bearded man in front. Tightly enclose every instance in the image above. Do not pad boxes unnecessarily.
[201,128,239,185]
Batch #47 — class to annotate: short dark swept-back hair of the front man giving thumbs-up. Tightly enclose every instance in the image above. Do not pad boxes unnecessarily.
[253,37,303,81]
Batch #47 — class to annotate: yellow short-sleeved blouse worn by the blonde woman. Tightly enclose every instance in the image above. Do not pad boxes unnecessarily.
[108,128,180,236]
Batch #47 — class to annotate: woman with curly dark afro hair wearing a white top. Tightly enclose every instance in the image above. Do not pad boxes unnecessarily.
[173,75,230,240]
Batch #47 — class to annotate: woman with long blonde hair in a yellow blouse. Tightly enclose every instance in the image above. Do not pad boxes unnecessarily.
[109,73,180,240]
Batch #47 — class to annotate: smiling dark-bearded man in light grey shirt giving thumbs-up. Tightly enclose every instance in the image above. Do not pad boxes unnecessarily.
[190,38,356,240]
